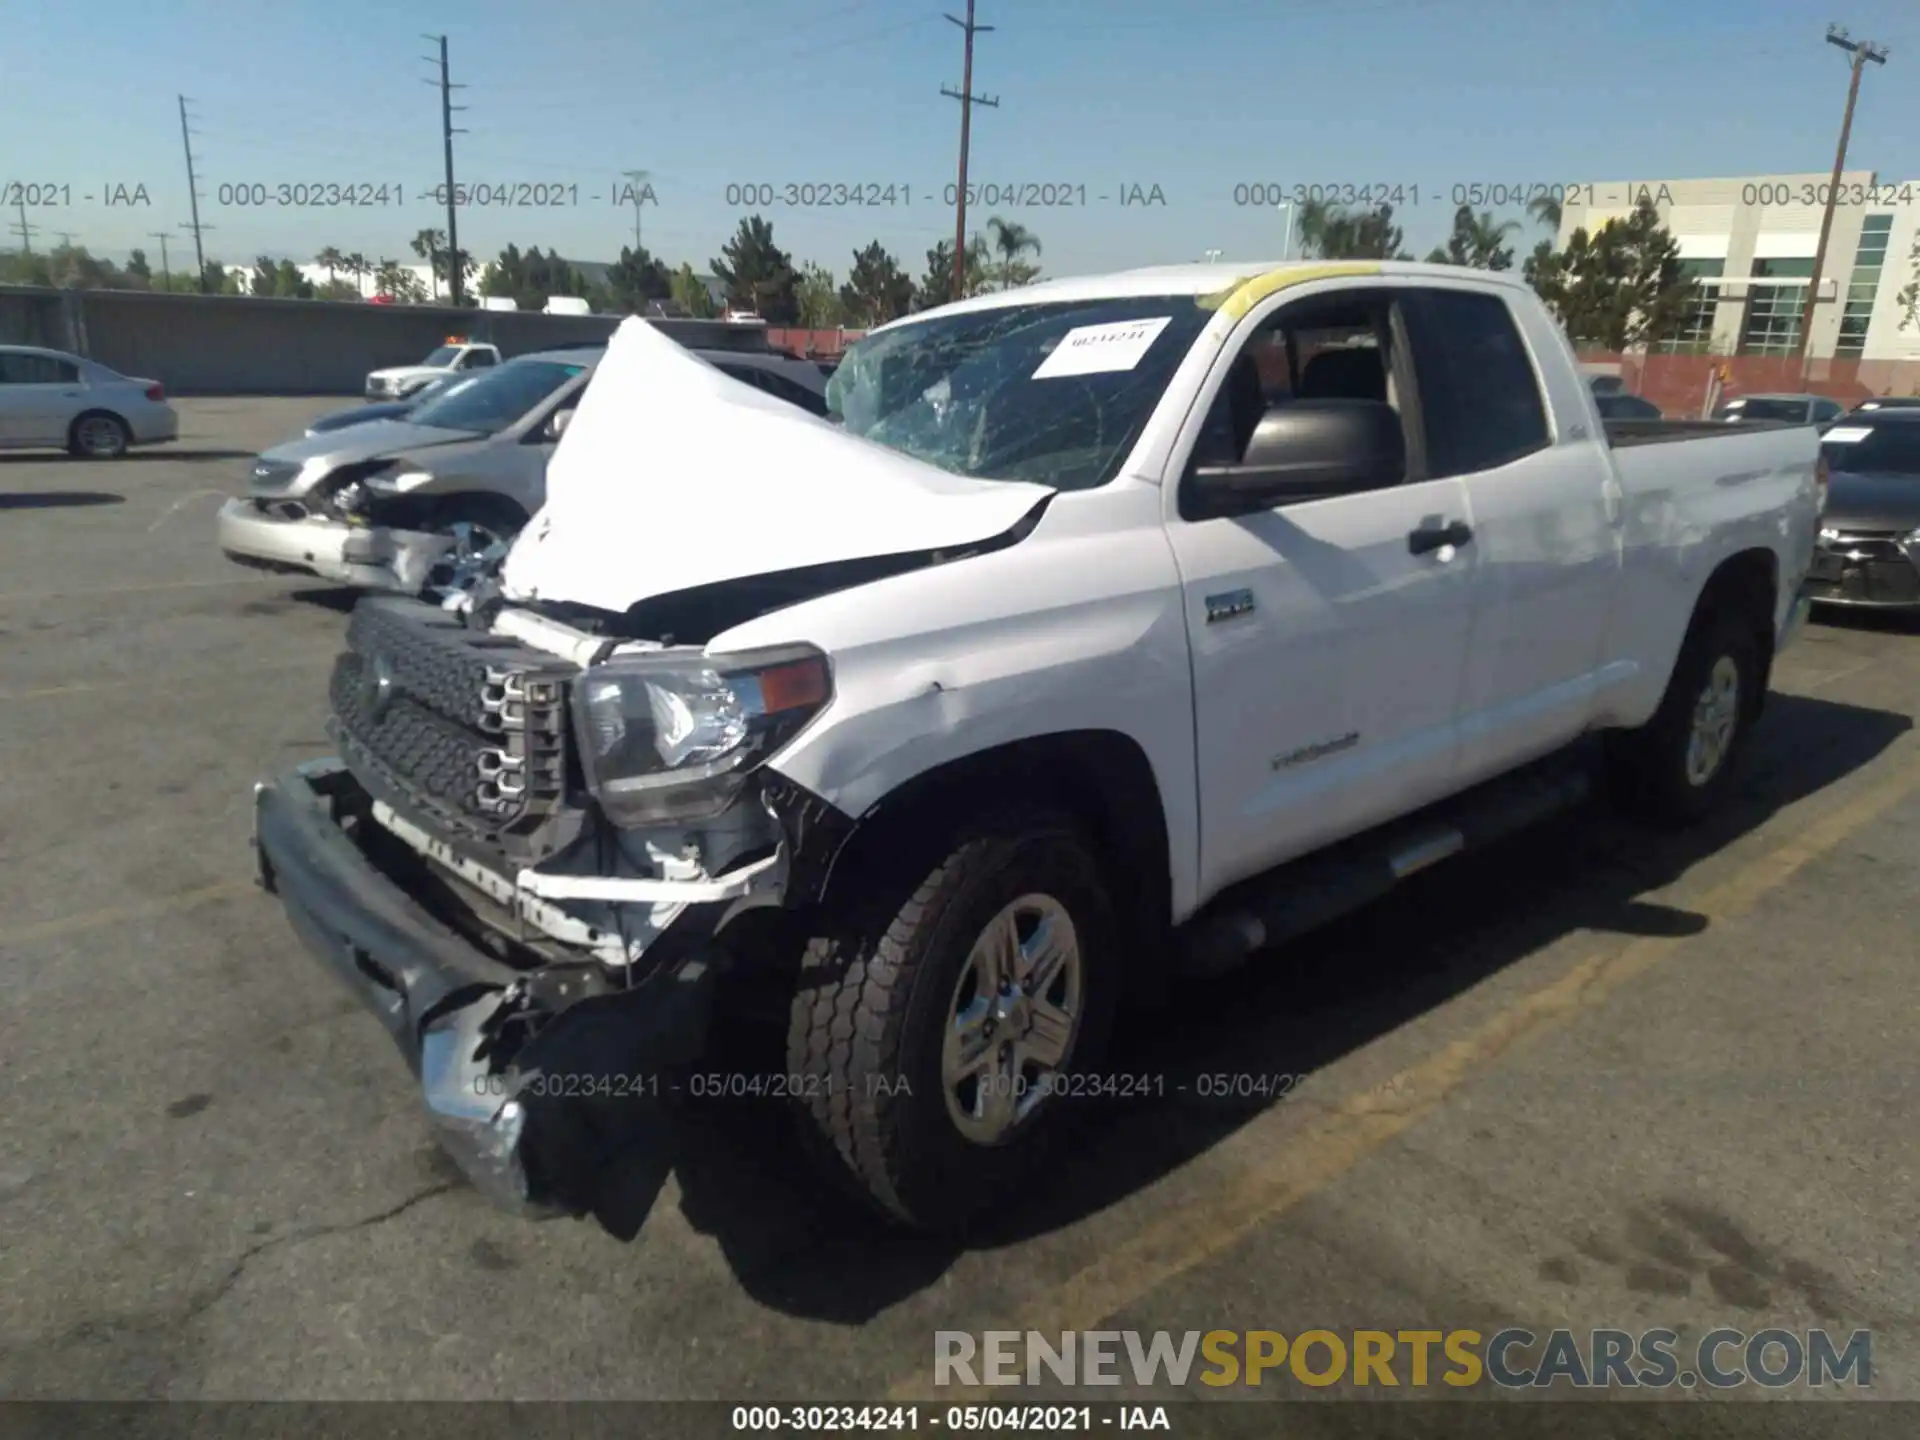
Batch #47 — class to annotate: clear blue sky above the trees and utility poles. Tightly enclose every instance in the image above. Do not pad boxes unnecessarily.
[0,0,1920,284]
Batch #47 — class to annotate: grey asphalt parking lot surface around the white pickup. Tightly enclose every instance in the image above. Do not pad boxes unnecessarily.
[0,399,1920,1428]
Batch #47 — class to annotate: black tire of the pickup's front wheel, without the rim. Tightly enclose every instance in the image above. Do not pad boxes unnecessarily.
[787,812,1119,1231]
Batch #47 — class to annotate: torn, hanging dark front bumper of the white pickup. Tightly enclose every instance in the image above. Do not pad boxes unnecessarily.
[255,760,718,1233]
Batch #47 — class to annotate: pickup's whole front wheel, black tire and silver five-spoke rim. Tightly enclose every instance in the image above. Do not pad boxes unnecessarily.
[787,814,1119,1229]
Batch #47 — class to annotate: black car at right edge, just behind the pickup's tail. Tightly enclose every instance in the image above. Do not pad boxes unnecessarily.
[1807,407,1920,609]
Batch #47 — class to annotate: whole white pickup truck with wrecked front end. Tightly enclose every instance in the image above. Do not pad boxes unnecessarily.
[255,263,1824,1235]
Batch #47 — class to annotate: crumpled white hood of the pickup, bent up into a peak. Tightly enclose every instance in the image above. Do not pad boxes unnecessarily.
[501,317,1054,612]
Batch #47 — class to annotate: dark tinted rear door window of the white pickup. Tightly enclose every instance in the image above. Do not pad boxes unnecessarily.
[1402,290,1549,480]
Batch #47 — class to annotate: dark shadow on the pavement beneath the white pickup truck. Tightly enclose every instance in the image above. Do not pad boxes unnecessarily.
[625,693,1912,1325]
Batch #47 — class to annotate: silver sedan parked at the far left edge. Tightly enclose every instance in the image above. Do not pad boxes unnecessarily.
[0,346,180,461]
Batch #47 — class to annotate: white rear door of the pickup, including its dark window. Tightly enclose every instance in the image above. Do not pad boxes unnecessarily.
[1404,286,1622,785]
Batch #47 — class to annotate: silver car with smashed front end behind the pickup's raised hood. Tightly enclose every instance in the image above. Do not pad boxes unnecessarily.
[219,346,826,595]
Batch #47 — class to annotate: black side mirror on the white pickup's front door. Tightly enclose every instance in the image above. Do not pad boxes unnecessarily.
[1181,399,1407,520]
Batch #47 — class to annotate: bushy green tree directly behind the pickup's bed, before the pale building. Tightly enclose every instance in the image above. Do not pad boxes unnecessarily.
[1523,198,1699,351]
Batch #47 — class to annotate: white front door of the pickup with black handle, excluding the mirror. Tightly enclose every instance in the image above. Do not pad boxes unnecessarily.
[1169,282,1478,900]
